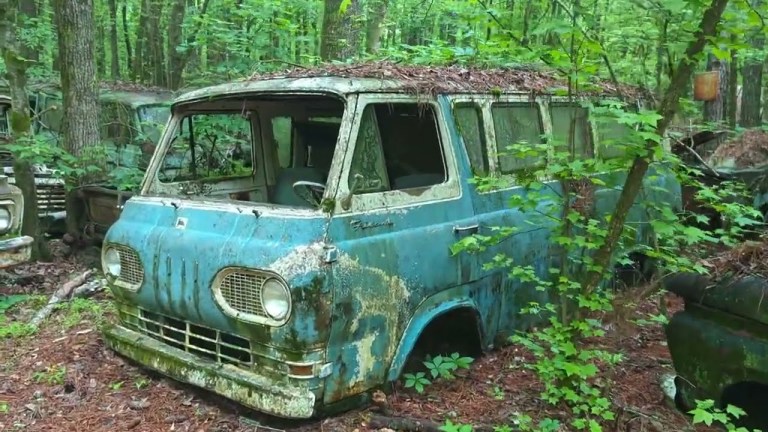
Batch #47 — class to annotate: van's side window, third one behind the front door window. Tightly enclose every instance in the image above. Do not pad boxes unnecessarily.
[549,102,594,158]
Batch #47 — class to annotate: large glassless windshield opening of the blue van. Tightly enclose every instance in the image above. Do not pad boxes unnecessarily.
[149,94,344,208]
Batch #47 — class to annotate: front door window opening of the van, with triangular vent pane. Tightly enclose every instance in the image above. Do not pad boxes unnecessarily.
[348,103,447,194]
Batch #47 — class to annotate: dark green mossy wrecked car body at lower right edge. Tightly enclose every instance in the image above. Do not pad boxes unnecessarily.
[665,268,768,430]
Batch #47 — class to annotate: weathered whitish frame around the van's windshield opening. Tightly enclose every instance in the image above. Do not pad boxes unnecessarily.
[137,90,357,215]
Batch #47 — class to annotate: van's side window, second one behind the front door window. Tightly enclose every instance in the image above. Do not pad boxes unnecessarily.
[491,103,546,174]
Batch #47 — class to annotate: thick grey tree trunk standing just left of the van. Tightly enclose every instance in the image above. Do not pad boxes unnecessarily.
[55,0,99,244]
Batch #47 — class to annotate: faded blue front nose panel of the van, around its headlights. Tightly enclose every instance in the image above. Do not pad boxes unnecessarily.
[104,196,332,351]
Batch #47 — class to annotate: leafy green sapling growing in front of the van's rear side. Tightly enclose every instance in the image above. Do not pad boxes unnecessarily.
[452,93,759,426]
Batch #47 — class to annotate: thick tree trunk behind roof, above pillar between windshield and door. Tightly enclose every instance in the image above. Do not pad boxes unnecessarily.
[320,0,361,61]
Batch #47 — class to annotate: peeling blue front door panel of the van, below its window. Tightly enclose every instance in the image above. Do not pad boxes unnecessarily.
[318,93,486,402]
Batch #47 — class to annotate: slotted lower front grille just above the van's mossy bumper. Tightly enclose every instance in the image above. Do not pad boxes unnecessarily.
[120,309,253,366]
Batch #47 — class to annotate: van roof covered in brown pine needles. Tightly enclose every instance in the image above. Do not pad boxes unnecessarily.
[174,62,645,103]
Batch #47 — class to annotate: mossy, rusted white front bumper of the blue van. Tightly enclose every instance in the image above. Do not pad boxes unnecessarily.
[103,325,315,419]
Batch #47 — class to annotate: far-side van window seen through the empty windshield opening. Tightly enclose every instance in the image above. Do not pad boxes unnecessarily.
[158,112,253,183]
